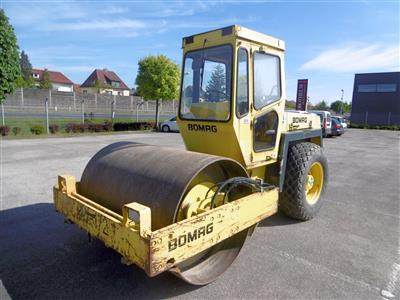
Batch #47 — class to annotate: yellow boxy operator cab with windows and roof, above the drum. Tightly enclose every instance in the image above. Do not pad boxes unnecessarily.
[178,25,285,168]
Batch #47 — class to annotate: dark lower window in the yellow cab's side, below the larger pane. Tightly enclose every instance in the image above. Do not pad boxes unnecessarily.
[254,111,279,152]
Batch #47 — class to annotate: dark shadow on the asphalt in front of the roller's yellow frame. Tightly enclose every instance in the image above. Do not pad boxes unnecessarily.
[0,203,198,299]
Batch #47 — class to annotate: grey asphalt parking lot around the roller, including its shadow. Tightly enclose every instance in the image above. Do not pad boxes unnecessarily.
[0,130,400,300]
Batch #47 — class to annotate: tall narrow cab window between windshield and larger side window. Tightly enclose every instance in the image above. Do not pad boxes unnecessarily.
[236,48,249,118]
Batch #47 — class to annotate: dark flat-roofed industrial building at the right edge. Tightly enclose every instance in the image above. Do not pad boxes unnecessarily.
[351,72,400,125]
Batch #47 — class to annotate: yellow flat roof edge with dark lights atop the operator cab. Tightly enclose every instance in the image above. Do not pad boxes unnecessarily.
[182,25,285,51]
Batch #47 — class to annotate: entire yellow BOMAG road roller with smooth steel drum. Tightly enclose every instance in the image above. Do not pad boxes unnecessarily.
[54,25,328,285]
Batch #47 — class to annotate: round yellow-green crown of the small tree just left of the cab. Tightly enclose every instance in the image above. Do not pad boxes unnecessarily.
[136,55,180,100]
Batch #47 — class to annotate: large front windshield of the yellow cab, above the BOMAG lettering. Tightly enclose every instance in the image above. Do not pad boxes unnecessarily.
[180,45,232,121]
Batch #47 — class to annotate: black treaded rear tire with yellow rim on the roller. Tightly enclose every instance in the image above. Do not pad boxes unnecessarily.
[279,142,328,221]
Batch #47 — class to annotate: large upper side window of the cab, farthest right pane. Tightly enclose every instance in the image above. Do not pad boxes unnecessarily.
[254,52,281,109]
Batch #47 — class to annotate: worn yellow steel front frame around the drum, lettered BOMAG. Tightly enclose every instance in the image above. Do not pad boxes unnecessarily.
[54,175,278,276]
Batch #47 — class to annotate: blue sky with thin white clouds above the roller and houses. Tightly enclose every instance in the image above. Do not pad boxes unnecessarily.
[0,0,400,104]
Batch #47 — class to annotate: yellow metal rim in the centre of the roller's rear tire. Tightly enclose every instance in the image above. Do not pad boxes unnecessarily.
[305,162,324,205]
